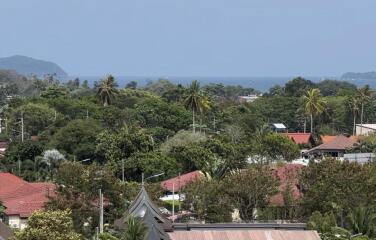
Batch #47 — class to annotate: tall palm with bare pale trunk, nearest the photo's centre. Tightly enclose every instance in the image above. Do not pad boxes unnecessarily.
[184,80,206,133]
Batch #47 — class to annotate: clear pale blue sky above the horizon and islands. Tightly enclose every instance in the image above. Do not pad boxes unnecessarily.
[0,0,376,77]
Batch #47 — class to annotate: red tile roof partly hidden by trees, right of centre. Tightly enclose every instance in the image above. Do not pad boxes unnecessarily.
[270,164,304,207]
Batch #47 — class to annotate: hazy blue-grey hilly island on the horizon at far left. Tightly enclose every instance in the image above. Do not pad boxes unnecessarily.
[0,55,68,78]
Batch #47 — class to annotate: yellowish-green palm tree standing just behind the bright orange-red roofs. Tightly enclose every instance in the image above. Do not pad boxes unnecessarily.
[304,88,326,133]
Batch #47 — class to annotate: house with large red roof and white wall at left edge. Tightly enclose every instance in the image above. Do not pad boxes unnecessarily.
[0,173,55,229]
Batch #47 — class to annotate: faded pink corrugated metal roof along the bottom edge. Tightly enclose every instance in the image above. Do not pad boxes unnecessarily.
[169,230,320,240]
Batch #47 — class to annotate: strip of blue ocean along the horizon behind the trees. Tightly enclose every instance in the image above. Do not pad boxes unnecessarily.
[70,76,376,92]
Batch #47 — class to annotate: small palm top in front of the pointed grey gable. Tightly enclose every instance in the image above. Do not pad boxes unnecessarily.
[122,216,148,240]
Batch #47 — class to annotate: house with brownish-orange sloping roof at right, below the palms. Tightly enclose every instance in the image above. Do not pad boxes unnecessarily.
[305,135,357,157]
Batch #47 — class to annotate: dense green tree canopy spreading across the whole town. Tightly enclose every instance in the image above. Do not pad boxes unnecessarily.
[0,72,376,239]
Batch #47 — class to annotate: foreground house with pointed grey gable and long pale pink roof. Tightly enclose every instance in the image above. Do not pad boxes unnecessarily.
[114,186,320,240]
